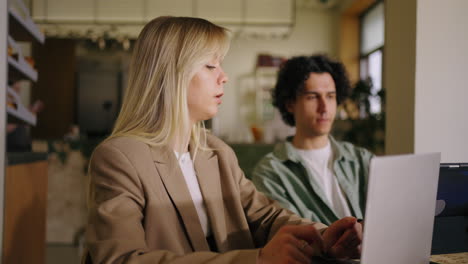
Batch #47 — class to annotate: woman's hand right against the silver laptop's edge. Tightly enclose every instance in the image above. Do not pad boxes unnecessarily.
[323,217,362,259]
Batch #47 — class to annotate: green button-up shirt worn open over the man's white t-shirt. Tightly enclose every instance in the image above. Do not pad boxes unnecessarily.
[252,137,373,225]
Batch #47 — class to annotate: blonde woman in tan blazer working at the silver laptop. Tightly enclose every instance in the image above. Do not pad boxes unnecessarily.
[86,17,361,264]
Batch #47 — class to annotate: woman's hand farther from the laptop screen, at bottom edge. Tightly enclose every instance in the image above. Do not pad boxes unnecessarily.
[258,225,323,264]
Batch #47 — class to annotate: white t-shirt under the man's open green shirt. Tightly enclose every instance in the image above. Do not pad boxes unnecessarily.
[296,141,351,218]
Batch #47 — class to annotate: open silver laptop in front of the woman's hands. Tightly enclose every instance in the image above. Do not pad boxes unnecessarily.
[313,153,440,264]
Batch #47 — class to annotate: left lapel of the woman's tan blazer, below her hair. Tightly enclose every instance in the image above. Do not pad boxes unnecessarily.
[151,147,210,251]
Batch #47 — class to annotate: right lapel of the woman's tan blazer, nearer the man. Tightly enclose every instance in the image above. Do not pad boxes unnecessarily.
[191,147,228,252]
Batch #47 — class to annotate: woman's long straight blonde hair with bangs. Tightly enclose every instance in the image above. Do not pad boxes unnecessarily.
[109,16,229,151]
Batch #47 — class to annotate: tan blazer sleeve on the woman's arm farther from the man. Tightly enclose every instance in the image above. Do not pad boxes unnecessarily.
[86,143,259,264]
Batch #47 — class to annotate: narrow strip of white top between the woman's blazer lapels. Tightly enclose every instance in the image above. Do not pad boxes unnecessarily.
[174,151,211,237]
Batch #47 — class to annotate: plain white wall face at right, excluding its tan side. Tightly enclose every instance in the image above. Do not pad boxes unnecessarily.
[414,0,468,162]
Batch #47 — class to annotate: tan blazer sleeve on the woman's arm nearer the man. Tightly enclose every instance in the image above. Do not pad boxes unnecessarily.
[225,148,327,247]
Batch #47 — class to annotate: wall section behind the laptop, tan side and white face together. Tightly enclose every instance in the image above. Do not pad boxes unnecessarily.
[384,0,468,162]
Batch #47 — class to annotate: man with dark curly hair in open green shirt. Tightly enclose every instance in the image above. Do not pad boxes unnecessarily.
[252,55,373,224]
